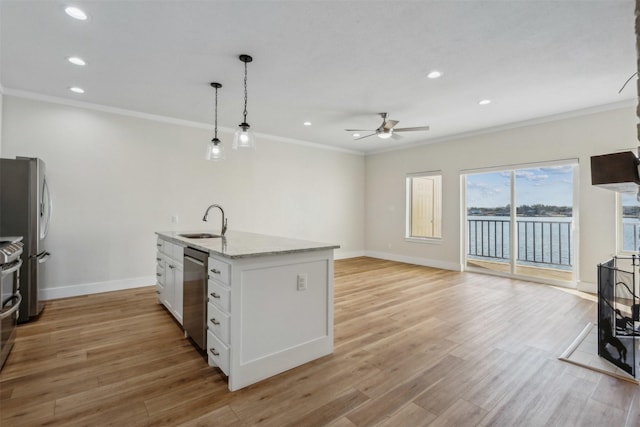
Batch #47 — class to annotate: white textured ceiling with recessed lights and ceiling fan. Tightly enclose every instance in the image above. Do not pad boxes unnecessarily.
[0,0,636,152]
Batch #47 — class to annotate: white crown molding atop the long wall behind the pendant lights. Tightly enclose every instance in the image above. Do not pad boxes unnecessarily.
[4,89,365,157]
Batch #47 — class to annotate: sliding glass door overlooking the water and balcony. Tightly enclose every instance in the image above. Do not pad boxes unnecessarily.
[464,162,577,282]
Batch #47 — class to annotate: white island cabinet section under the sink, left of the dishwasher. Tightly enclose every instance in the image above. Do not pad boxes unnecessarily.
[156,238,184,324]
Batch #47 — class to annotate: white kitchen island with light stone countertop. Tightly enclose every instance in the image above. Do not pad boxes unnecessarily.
[156,231,339,391]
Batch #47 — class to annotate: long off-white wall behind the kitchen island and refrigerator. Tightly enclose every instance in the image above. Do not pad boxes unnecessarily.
[1,94,365,298]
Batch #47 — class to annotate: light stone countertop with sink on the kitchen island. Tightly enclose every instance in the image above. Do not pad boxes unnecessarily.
[156,230,340,259]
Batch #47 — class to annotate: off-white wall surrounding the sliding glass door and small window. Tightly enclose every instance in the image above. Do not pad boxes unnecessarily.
[365,107,638,292]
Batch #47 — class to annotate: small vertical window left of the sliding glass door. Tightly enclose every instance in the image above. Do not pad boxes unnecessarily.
[406,173,442,239]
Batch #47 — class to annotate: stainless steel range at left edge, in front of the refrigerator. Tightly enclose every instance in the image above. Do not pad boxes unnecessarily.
[0,237,24,370]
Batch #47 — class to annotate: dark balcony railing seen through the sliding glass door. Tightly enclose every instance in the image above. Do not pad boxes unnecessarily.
[467,218,572,268]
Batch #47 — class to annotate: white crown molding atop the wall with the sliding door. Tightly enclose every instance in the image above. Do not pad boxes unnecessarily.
[366,98,638,155]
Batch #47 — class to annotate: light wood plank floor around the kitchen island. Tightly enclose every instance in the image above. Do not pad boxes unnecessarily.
[0,258,640,427]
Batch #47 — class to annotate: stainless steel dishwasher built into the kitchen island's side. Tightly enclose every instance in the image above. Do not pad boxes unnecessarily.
[182,247,209,350]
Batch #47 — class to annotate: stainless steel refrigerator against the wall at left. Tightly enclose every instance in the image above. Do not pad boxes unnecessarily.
[0,157,52,323]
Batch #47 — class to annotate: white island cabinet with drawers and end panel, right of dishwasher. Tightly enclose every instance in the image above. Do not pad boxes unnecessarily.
[207,250,333,391]
